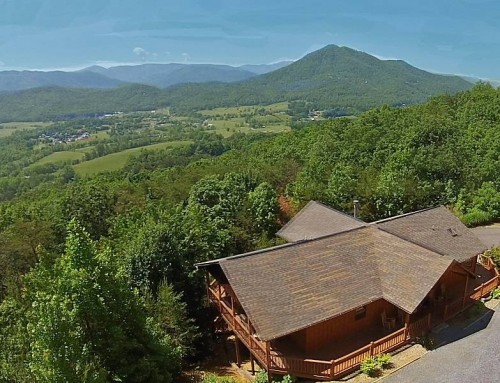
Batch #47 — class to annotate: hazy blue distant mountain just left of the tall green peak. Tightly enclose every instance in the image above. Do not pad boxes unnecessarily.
[82,63,256,88]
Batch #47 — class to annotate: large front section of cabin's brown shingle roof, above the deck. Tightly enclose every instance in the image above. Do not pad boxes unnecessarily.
[219,227,453,340]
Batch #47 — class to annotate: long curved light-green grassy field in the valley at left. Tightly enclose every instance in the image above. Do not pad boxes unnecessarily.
[73,141,191,176]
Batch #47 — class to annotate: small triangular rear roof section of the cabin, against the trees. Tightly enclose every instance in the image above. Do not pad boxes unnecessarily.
[276,201,366,242]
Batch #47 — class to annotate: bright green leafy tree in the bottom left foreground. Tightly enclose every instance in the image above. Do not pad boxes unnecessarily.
[22,220,179,382]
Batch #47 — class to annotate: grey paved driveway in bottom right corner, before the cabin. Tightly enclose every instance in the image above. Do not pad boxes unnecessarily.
[383,307,500,383]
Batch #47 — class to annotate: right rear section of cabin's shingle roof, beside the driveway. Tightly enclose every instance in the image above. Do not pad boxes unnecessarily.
[373,206,487,262]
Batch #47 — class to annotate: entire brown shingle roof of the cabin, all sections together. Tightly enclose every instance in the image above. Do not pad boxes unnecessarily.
[199,203,485,340]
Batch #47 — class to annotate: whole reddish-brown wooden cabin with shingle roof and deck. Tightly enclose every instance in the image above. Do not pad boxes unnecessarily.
[197,201,499,380]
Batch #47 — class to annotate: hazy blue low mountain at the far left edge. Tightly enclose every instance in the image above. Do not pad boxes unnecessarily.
[0,70,123,91]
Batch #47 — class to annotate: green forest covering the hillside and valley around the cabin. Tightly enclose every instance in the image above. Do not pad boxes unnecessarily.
[0,83,500,383]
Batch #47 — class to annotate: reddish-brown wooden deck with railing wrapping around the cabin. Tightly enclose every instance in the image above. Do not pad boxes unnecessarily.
[207,258,500,380]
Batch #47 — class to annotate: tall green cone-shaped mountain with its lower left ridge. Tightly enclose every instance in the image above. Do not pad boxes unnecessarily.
[163,45,472,114]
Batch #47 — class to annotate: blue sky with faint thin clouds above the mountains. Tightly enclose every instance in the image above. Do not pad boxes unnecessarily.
[0,0,500,79]
